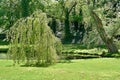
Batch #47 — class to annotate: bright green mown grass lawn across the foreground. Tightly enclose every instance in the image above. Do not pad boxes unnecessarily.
[0,58,120,80]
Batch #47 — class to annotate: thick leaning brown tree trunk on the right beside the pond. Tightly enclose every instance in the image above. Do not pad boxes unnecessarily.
[91,11,118,53]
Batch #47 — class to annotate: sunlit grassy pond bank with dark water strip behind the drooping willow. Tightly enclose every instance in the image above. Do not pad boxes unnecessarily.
[0,44,120,59]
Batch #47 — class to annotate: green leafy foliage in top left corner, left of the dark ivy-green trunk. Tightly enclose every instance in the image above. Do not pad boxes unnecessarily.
[0,0,21,29]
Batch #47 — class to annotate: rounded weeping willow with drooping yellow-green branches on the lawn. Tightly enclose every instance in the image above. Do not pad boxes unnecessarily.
[8,11,61,65]
